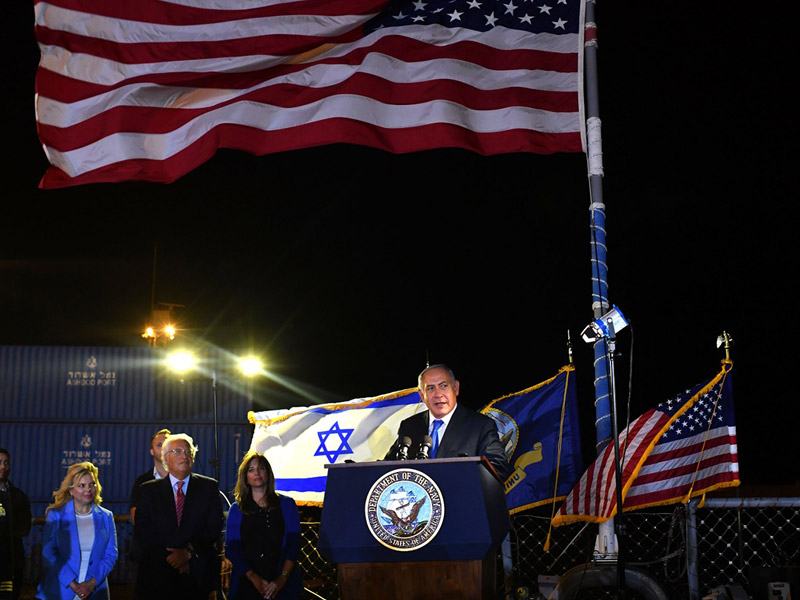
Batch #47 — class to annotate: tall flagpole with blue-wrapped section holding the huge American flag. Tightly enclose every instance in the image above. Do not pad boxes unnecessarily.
[584,0,625,594]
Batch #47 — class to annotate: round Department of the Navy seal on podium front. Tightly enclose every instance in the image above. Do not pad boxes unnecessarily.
[364,469,444,552]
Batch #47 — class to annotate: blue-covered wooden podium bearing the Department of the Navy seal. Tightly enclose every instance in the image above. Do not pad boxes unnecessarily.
[318,457,510,600]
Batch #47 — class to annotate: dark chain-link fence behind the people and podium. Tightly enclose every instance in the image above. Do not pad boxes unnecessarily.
[20,498,800,600]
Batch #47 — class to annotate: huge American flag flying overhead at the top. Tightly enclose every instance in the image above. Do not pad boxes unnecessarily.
[35,0,584,188]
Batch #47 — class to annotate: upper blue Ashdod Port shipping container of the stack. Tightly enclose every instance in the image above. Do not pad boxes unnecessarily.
[0,346,252,423]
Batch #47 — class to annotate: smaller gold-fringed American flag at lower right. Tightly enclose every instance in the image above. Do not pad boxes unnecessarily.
[553,360,739,525]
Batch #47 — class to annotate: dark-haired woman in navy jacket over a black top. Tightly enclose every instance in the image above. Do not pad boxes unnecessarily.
[225,451,303,600]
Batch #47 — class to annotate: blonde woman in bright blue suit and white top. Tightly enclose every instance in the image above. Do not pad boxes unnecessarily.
[36,462,117,600]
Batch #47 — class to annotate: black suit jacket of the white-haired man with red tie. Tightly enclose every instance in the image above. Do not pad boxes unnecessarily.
[133,473,223,600]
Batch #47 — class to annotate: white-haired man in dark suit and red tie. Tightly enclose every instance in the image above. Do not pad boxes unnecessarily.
[134,433,223,600]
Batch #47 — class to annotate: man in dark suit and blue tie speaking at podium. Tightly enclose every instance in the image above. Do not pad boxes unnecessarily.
[385,365,511,481]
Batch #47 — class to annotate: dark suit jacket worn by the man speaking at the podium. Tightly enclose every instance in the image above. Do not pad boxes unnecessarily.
[385,404,511,481]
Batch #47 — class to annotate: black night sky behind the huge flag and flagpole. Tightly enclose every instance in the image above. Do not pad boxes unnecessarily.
[0,3,798,484]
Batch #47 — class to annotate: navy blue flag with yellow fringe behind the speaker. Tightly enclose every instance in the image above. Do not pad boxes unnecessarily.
[481,366,583,514]
